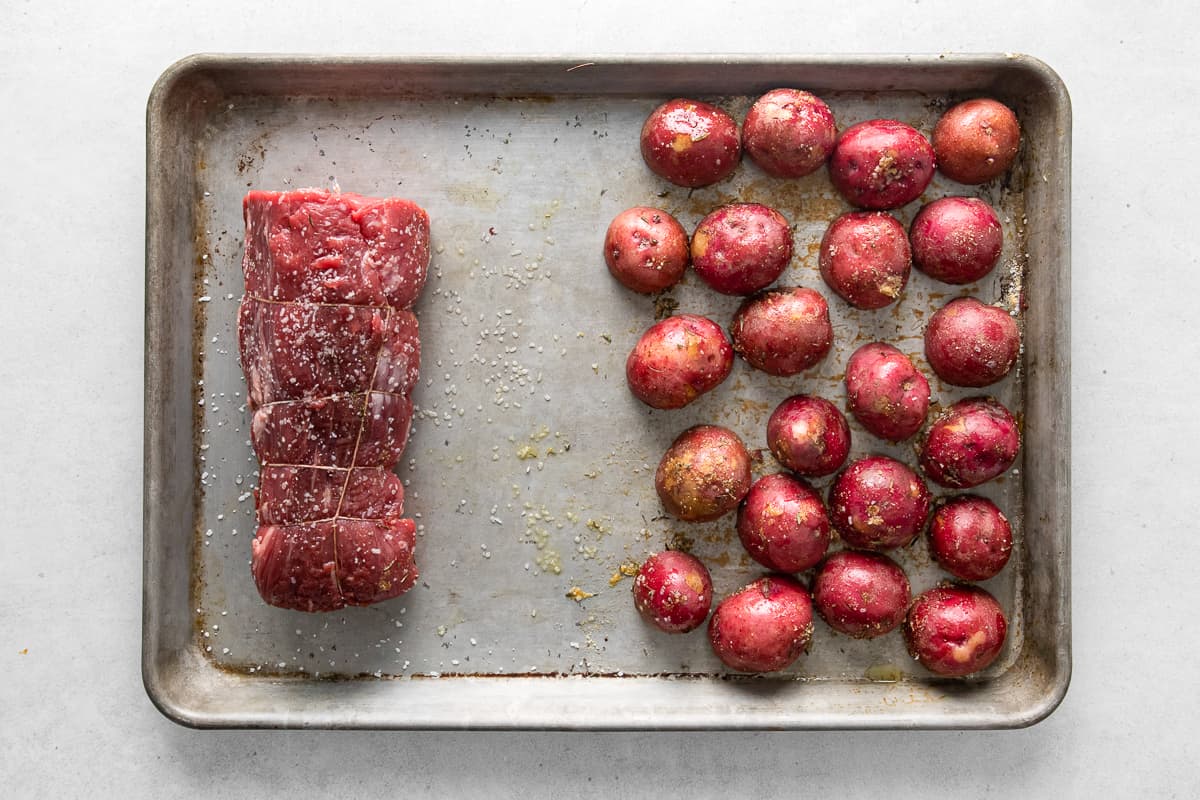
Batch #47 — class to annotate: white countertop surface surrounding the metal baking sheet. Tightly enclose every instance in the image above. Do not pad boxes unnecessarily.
[0,0,1200,798]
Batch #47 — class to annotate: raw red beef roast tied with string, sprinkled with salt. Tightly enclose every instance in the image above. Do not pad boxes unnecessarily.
[238,190,430,612]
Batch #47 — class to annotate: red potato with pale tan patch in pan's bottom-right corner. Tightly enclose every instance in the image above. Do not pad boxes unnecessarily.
[904,585,1008,678]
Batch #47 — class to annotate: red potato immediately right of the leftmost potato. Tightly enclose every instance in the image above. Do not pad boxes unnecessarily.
[691,203,792,295]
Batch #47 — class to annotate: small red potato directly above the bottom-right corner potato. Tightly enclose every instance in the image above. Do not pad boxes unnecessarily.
[929,494,1013,581]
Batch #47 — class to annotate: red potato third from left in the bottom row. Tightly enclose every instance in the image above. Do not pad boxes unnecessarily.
[812,551,911,639]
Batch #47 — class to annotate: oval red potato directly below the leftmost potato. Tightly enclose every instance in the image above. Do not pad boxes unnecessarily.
[625,314,733,409]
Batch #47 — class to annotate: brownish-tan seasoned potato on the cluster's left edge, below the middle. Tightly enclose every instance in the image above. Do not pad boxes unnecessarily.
[654,425,751,522]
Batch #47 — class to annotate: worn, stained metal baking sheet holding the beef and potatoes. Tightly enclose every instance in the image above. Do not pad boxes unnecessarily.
[143,55,1070,729]
